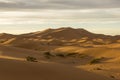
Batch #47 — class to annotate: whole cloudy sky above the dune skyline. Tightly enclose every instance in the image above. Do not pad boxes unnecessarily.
[0,0,120,35]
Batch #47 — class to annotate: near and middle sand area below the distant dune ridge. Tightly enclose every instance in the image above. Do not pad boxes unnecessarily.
[0,44,120,80]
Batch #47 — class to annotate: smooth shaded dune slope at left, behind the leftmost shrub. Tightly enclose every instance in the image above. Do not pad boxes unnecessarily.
[0,45,41,59]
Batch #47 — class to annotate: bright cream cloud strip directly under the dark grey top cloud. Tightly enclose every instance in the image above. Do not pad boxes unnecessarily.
[0,8,120,19]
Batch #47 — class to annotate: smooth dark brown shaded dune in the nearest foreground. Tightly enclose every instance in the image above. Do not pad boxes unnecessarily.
[0,59,112,80]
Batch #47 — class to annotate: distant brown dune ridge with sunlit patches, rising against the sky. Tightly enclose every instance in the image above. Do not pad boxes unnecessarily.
[0,27,120,47]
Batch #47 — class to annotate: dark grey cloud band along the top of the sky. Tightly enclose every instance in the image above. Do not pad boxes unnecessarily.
[0,0,120,9]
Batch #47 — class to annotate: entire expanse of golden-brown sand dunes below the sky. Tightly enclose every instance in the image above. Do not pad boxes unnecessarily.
[0,27,120,80]
